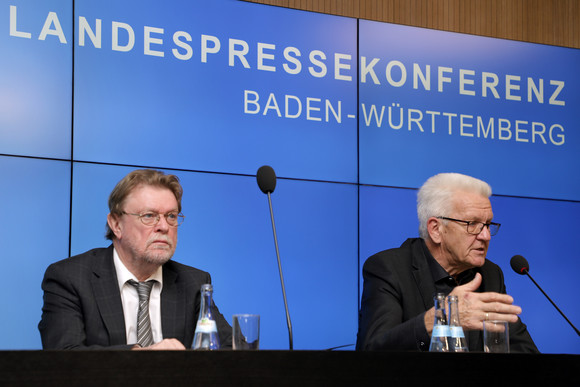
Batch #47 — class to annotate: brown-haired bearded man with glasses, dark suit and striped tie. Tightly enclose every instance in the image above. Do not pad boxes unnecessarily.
[38,169,231,350]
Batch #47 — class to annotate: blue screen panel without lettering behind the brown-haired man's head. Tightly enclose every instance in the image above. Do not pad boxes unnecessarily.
[72,163,358,349]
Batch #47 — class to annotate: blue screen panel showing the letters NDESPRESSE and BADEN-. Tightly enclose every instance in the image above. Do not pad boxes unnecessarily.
[74,0,357,182]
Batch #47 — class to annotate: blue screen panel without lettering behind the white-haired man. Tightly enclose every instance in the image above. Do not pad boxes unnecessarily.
[360,186,580,353]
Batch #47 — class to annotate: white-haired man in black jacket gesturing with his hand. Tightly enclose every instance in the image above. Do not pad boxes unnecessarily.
[356,173,538,352]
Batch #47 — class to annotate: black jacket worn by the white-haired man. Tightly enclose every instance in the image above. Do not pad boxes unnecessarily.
[356,238,538,352]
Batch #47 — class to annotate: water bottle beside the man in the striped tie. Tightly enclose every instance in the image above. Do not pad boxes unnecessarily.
[193,284,220,350]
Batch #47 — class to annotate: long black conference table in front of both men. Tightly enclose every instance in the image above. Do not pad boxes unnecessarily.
[0,350,580,387]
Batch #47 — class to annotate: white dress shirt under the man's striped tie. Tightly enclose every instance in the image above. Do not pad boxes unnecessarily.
[113,249,163,344]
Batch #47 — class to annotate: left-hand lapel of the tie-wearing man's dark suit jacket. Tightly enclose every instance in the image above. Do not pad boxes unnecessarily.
[91,246,127,345]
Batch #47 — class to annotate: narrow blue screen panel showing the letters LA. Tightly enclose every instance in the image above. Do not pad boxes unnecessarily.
[0,0,72,158]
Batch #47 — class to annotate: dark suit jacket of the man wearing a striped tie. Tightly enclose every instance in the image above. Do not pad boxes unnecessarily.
[38,249,232,349]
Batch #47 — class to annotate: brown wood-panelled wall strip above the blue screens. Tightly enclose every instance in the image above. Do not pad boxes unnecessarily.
[247,0,580,48]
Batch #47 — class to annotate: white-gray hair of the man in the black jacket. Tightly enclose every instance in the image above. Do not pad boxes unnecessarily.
[417,173,491,239]
